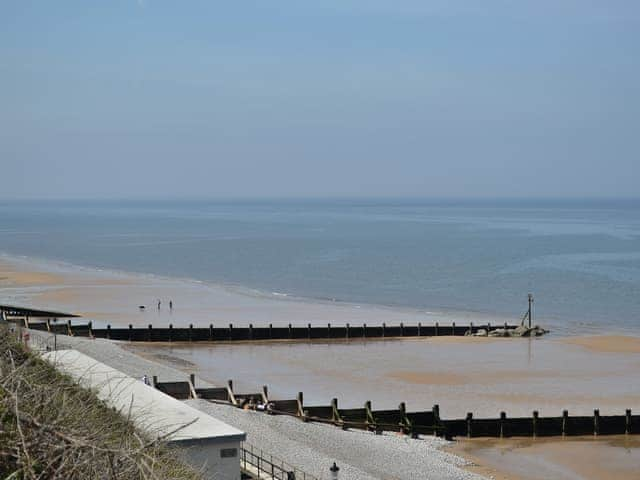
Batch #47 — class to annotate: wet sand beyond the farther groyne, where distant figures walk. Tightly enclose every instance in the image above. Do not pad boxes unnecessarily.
[0,256,490,326]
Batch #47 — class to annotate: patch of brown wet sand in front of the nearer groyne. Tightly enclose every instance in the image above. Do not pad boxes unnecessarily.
[449,436,640,480]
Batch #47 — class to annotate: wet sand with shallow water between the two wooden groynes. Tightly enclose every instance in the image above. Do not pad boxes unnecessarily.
[135,337,640,418]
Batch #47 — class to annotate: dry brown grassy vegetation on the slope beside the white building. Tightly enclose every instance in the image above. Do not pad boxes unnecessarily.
[0,323,200,480]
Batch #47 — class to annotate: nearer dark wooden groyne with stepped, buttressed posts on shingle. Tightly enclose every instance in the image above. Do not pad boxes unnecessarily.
[153,375,640,438]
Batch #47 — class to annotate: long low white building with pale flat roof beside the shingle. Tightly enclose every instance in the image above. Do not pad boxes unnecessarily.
[43,350,246,480]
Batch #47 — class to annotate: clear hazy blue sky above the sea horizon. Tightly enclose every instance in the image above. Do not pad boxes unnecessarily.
[0,0,640,199]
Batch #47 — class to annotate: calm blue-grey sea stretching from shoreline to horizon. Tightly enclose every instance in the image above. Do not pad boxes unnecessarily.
[0,200,640,329]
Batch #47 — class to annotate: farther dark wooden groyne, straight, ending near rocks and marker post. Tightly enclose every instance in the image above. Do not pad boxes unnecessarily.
[9,318,517,342]
